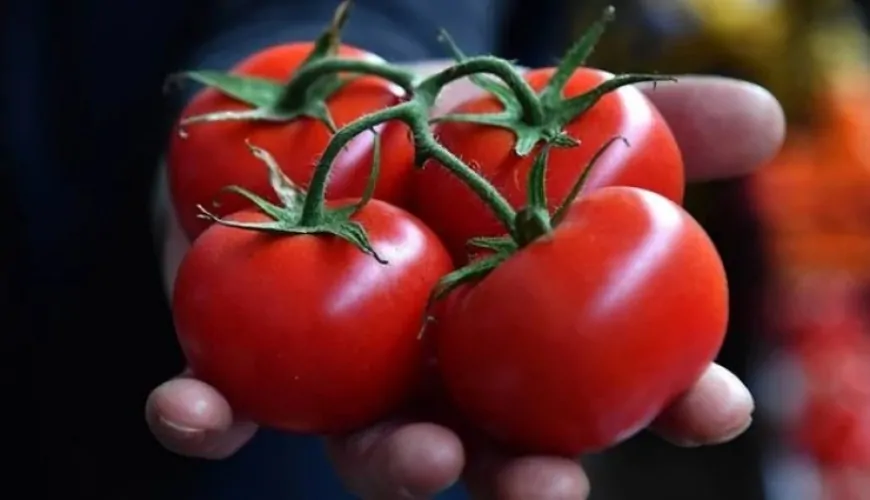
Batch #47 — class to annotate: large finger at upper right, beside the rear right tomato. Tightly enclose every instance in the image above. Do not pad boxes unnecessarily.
[643,76,785,180]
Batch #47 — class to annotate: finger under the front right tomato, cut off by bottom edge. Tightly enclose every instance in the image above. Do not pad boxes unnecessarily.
[465,451,589,500]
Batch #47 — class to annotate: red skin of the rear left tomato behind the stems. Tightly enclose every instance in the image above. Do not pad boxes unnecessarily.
[168,42,414,239]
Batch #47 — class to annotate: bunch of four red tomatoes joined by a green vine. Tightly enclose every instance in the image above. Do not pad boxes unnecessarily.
[168,2,728,455]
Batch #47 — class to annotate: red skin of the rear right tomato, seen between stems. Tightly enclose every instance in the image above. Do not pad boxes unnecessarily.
[412,68,684,262]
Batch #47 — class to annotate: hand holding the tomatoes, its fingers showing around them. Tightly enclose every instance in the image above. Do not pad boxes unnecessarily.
[146,64,785,499]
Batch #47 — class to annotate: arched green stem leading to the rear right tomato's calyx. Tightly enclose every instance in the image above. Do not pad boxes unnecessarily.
[417,56,545,126]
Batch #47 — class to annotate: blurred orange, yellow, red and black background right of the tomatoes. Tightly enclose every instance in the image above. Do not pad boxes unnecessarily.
[552,0,870,500]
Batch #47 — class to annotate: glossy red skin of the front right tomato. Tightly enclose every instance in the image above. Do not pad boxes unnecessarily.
[436,187,728,456]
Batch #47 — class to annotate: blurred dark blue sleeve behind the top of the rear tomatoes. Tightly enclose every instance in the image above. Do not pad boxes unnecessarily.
[188,0,509,73]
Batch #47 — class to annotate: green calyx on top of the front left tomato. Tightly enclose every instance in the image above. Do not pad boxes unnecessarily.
[197,140,387,264]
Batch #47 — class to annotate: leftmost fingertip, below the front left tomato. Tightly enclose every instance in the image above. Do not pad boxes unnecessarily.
[145,377,257,459]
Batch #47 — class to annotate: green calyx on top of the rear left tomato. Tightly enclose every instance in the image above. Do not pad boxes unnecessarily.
[169,0,382,136]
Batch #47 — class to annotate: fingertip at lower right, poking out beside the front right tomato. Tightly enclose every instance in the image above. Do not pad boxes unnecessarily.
[652,364,755,446]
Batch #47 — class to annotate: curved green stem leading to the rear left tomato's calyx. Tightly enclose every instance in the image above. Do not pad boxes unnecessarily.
[278,57,415,109]
